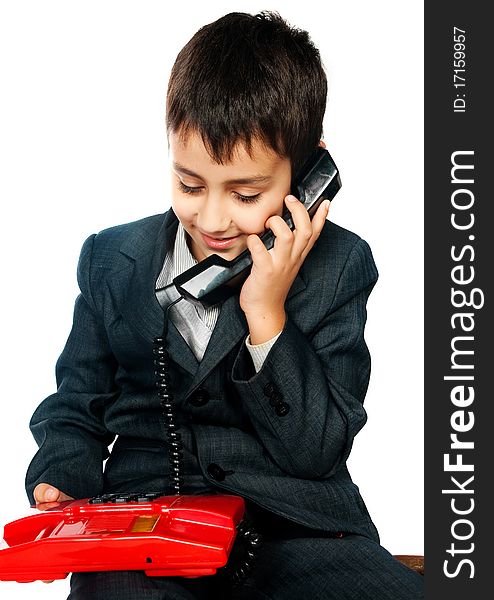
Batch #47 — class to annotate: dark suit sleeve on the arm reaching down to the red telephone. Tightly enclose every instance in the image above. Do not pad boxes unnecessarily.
[25,235,118,504]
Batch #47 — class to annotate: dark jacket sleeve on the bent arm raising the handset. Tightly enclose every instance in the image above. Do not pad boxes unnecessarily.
[232,239,378,479]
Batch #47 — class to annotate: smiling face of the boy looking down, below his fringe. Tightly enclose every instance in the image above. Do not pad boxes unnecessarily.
[169,132,291,261]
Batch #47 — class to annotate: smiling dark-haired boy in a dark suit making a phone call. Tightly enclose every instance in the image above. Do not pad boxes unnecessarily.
[26,12,422,600]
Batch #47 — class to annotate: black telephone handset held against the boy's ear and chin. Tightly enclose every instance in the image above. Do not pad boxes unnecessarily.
[157,147,341,307]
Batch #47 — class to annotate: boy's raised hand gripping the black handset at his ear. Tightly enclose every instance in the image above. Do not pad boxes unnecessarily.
[239,194,330,344]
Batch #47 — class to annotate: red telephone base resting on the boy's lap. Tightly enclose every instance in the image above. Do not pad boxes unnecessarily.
[0,492,245,582]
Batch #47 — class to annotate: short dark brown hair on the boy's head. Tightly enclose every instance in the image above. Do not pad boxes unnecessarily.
[166,11,327,174]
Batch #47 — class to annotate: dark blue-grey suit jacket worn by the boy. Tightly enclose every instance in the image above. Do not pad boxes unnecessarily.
[26,209,378,540]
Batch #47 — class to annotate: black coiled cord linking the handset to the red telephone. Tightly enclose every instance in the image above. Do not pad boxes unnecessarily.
[153,296,262,587]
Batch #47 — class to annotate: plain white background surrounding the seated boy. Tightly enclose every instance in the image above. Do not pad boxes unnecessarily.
[0,0,423,600]
